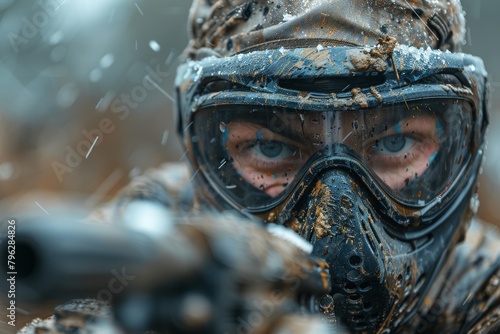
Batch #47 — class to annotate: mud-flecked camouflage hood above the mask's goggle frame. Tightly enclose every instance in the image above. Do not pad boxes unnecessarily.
[187,0,465,58]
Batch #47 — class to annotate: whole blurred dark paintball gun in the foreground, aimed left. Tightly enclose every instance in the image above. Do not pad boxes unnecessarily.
[0,202,332,334]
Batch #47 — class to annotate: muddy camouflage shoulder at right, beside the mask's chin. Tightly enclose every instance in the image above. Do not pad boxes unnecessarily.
[418,220,500,333]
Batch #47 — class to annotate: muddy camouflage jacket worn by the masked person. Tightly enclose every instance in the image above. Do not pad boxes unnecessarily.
[20,164,500,333]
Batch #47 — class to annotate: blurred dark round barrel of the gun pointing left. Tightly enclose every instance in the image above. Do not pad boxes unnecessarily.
[0,220,200,302]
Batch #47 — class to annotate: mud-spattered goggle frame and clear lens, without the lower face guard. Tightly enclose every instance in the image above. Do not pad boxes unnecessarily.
[178,41,485,217]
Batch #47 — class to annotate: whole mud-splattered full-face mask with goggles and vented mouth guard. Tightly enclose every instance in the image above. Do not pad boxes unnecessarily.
[176,39,487,331]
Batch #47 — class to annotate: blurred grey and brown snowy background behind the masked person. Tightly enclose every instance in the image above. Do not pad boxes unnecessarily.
[0,0,500,219]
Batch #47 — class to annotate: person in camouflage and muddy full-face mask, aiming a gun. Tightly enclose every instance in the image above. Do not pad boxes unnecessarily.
[15,0,500,333]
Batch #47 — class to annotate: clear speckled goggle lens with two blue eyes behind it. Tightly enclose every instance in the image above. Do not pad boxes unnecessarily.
[192,99,473,210]
